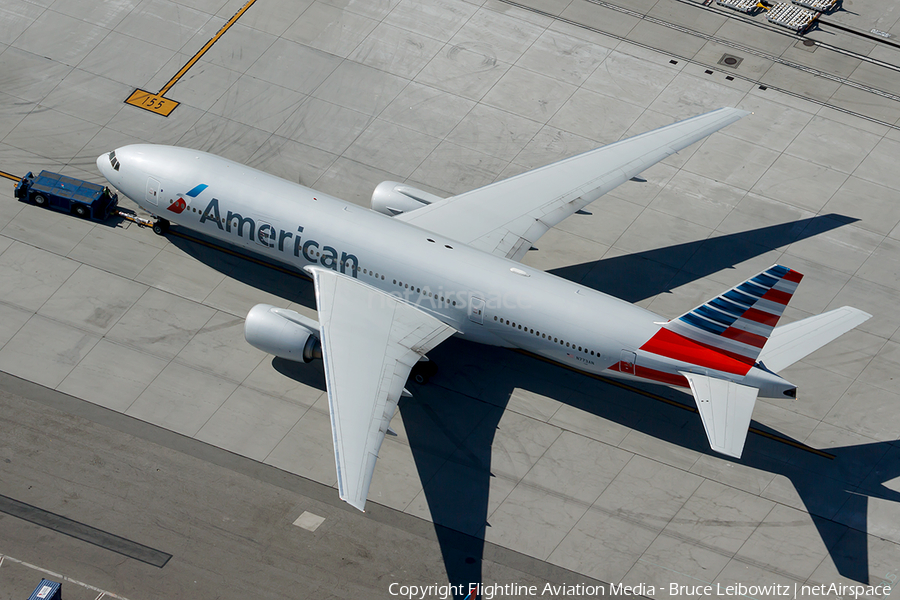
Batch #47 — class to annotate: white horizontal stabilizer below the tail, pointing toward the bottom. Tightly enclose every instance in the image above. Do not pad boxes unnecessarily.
[681,372,759,458]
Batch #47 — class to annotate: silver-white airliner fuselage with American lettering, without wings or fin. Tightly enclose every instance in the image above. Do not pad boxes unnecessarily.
[97,145,790,397]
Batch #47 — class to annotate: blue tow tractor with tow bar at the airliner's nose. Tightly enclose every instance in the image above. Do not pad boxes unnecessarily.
[15,171,153,226]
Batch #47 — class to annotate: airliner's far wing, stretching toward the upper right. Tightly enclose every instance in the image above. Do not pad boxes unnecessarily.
[394,108,749,261]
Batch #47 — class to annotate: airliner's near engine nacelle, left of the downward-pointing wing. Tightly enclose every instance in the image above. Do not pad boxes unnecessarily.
[244,304,322,362]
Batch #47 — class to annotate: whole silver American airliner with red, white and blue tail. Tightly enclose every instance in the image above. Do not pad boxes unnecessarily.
[97,108,871,510]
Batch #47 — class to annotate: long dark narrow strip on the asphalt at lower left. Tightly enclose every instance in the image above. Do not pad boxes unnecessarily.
[0,494,172,569]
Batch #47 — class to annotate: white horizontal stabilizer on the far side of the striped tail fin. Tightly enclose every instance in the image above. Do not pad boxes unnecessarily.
[759,306,872,373]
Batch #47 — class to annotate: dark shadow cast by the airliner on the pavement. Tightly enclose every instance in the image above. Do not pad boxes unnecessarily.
[162,214,884,598]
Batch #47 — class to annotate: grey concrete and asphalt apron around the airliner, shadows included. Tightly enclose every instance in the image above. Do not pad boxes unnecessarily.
[0,0,900,599]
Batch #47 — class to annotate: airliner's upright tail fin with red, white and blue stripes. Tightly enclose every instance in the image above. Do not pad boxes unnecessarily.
[663,265,803,365]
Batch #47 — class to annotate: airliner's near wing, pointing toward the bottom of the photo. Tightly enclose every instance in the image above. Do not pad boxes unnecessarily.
[307,268,455,510]
